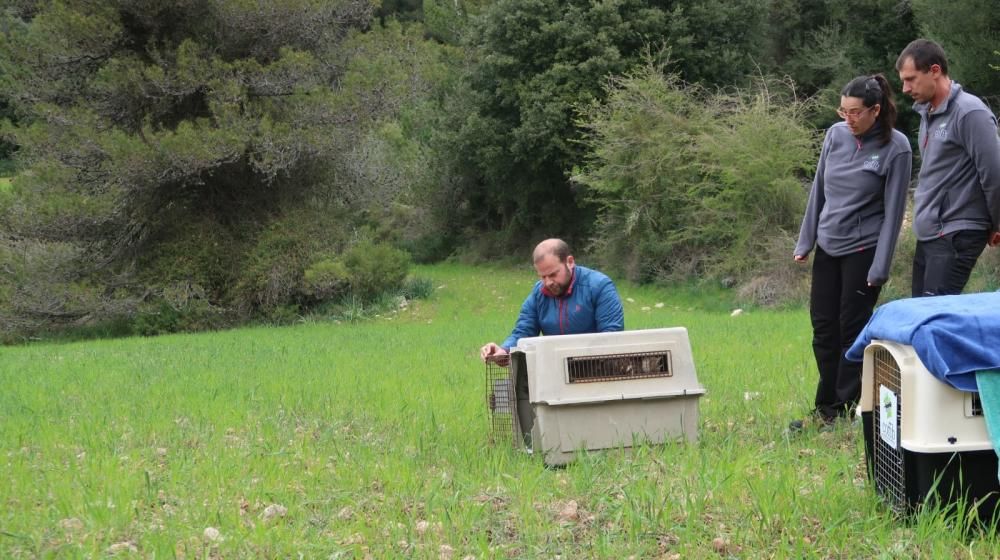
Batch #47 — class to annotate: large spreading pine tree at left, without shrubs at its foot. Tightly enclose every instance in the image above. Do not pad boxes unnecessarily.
[0,0,377,332]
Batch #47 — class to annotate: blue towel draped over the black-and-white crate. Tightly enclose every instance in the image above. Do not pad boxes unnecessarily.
[846,292,1000,391]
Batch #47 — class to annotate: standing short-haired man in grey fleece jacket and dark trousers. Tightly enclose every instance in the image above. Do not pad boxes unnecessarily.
[896,39,1000,297]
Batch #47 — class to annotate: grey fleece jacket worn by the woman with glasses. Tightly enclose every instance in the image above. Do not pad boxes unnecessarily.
[795,122,912,286]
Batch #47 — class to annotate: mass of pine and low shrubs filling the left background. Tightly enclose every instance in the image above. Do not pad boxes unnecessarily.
[0,4,448,335]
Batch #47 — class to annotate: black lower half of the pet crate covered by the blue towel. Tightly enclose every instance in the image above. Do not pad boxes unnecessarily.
[861,411,1000,527]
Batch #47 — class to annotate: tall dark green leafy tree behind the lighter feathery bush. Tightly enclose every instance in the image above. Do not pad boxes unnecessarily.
[457,0,763,252]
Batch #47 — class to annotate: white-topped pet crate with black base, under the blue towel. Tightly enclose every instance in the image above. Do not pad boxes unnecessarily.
[860,340,1000,521]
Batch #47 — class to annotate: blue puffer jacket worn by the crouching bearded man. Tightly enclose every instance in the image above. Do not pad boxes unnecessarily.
[500,265,625,350]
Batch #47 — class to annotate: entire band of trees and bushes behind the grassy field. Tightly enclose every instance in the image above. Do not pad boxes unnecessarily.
[0,0,1000,342]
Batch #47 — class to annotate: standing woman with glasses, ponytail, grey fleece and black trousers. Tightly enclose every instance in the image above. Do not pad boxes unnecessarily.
[791,74,912,429]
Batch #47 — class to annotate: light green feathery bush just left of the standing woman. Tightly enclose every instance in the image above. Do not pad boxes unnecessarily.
[575,67,817,288]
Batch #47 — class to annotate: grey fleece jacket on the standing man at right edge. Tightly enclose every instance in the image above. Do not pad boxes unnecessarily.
[913,82,1000,241]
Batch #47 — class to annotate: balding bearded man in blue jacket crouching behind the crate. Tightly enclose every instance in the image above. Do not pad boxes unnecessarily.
[479,239,625,361]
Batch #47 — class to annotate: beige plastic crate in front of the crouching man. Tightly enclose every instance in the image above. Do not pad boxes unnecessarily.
[512,327,705,465]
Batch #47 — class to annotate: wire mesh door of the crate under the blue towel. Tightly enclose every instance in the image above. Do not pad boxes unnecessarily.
[872,348,907,513]
